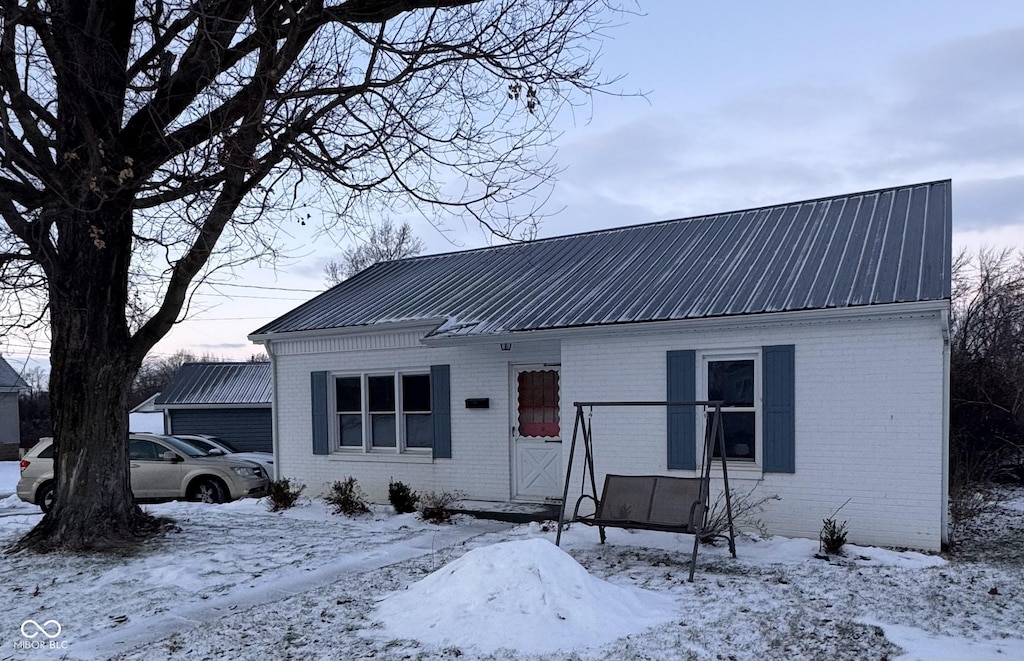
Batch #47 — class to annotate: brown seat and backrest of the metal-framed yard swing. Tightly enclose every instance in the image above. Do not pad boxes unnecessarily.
[578,475,707,533]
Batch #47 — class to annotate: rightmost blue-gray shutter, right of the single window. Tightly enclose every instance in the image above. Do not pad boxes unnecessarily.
[761,344,797,473]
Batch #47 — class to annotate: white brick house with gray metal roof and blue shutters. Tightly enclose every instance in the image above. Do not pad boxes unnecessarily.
[250,181,951,549]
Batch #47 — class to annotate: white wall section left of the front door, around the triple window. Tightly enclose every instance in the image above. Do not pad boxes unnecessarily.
[276,333,558,502]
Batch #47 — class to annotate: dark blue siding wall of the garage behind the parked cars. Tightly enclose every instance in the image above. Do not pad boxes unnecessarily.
[169,408,273,452]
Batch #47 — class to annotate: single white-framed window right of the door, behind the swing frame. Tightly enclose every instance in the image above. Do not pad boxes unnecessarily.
[699,352,761,462]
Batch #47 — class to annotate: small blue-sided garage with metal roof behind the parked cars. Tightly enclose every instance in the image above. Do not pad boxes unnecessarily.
[154,362,272,452]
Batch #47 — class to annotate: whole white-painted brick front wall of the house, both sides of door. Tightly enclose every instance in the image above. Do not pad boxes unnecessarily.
[276,315,943,549]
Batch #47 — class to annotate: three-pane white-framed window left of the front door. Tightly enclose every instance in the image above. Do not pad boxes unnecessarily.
[333,372,433,452]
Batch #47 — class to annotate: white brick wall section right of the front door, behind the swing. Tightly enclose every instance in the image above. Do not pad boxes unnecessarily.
[562,317,943,549]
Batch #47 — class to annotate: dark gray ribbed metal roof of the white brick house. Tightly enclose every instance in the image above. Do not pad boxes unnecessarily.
[252,180,951,339]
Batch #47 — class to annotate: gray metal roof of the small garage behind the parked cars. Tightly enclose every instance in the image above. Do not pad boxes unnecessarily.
[154,362,270,406]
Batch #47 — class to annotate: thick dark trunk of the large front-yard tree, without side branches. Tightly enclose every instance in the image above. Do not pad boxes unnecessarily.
[8,0,174,552]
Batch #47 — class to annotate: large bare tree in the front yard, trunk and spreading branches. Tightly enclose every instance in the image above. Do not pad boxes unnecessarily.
[0,0,614,550]
